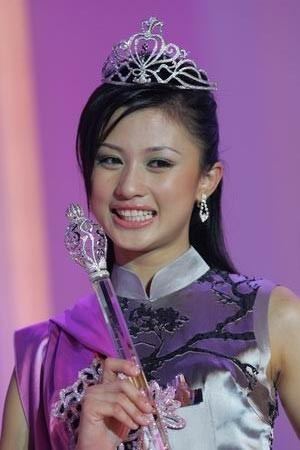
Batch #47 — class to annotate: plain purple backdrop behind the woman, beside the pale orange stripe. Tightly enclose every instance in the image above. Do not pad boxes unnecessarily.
[13,0,300,450]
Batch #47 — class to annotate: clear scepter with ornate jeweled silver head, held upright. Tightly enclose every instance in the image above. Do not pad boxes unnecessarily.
[65,204,170,450]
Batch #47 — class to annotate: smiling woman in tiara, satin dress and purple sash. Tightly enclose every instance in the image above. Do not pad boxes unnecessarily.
[1,18,300,450]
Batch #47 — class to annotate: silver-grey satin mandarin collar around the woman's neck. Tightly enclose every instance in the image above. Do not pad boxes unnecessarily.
[111,247,209,301]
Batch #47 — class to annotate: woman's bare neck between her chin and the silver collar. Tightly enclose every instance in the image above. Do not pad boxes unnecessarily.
[114,244,189,290]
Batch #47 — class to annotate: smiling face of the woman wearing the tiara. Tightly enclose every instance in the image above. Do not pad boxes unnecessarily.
[91,108,205,263]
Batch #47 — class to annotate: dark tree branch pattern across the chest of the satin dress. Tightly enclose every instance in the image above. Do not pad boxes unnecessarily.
[120,269,259,389]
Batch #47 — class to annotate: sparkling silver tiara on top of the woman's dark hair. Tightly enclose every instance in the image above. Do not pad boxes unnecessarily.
[102,17,217,90]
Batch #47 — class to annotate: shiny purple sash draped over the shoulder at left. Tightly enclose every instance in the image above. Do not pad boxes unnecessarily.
[15,295,115,450]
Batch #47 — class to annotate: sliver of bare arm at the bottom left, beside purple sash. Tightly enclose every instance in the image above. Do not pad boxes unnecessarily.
[0,374,28,450]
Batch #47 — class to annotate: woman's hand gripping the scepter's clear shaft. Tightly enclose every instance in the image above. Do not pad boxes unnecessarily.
[76,358,152,450]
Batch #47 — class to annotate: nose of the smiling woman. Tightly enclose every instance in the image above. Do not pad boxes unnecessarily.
[115,164,146,200]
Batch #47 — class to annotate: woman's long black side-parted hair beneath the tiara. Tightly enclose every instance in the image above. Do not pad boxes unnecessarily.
[76,83,235,272]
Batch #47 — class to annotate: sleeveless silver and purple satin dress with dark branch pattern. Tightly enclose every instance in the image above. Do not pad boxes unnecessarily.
[112,248,277,450]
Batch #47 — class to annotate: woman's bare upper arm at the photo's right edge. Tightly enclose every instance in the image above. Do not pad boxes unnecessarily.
[269,287,300,438]
